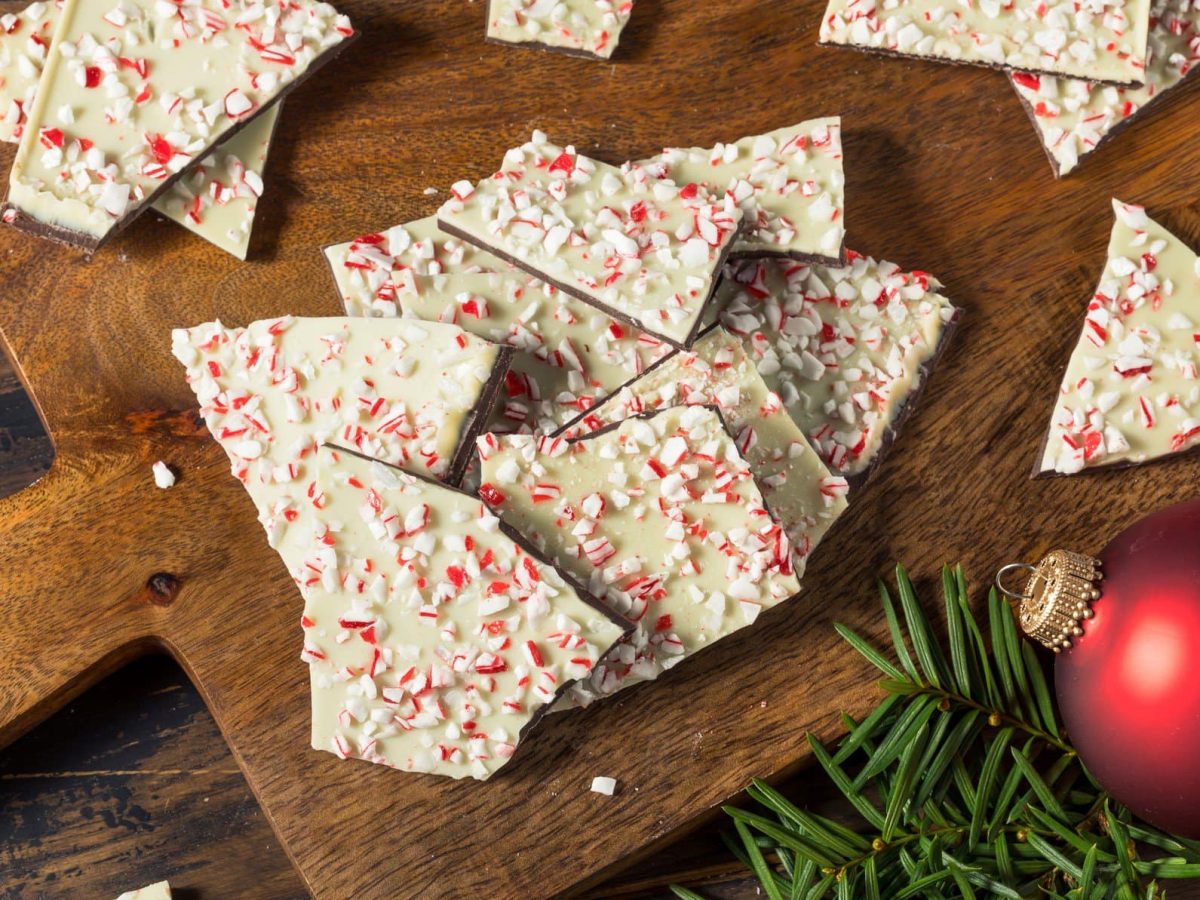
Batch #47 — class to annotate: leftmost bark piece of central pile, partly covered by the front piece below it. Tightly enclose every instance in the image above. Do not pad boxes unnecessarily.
[172,317,511,546]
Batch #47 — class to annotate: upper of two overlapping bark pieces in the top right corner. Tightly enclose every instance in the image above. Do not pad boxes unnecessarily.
[821,0,1151,85]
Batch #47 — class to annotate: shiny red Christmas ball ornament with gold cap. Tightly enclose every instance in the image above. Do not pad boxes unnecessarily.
[998,500,1200,839]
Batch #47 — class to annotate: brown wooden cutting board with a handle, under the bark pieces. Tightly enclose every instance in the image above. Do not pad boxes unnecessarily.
[0,0,1200,900]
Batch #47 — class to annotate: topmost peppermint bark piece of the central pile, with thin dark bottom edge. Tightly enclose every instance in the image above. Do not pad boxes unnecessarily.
[438,132,742,347]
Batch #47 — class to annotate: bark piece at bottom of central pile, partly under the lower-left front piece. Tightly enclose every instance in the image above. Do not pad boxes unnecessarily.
[479,407,799,704]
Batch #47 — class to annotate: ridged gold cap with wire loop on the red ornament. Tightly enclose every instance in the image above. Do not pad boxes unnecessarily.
[996,550,1103,653]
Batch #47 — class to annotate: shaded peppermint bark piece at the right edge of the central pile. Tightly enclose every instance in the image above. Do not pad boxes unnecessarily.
[720,251,958,478]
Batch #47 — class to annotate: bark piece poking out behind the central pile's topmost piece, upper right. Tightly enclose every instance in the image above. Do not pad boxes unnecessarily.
[638,116,846,263]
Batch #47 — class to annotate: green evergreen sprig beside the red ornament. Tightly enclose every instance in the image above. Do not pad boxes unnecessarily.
[672,566,1200,900]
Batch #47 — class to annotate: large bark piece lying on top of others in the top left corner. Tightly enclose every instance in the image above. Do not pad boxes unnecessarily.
[5,0,354,251]
